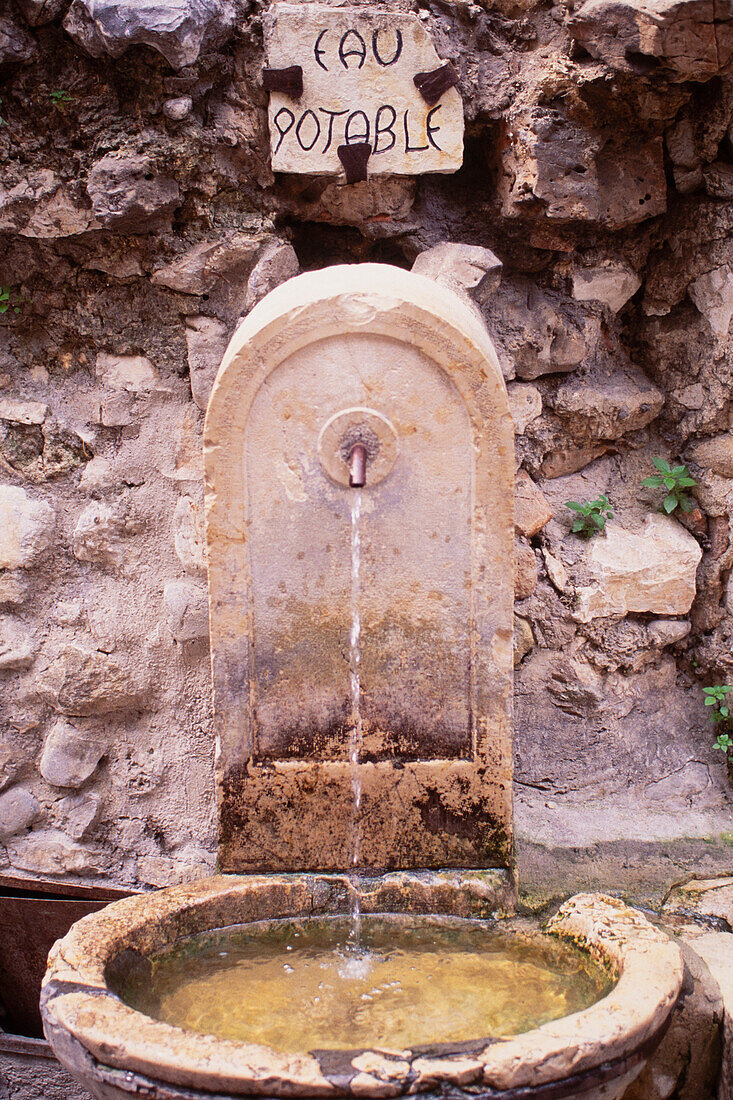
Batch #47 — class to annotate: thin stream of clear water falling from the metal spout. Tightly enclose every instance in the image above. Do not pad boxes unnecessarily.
[349,488,362,947]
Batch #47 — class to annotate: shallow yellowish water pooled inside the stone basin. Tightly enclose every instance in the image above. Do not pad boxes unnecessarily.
[119,916,613,1053]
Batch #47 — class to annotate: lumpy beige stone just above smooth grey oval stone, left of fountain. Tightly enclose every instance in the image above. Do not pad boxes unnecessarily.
[36,645,149,717]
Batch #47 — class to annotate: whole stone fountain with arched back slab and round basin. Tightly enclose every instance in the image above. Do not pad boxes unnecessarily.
[42,265,681,1100]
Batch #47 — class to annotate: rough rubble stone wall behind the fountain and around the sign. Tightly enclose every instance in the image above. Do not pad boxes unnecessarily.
[0,0,733,895]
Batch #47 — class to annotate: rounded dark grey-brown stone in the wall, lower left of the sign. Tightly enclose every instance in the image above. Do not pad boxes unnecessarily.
[85,151,180,233]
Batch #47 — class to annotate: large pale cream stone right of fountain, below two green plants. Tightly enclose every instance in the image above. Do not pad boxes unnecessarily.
[576,515,702,623]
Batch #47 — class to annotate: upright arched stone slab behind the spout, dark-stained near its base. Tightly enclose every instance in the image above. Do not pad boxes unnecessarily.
[205,264,514,871]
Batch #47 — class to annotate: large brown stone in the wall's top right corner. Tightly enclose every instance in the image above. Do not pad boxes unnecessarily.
[568,0,733,80]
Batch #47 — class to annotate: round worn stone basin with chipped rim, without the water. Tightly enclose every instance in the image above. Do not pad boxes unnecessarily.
[41,871,682,1100]
